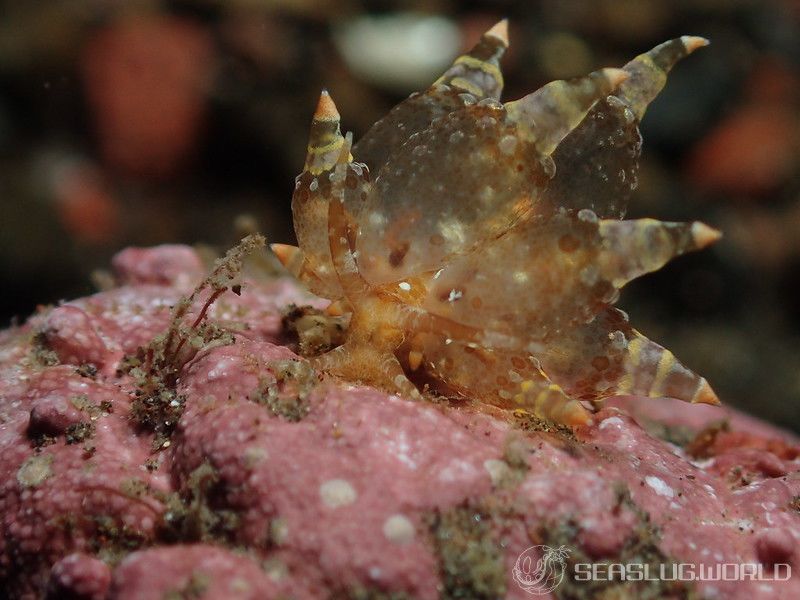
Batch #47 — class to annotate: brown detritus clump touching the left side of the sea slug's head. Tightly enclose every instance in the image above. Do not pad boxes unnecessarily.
[281,304,347,357]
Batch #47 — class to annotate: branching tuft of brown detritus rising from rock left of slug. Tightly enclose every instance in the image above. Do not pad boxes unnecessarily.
[125,234,266,451]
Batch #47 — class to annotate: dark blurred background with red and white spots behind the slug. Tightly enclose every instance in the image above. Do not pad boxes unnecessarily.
[0,0,800,430]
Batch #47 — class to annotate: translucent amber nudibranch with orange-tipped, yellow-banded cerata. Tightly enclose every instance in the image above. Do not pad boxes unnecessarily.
[273,21,720,426]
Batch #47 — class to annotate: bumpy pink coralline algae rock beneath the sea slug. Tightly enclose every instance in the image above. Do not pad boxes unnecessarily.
[0,246,800,600]
